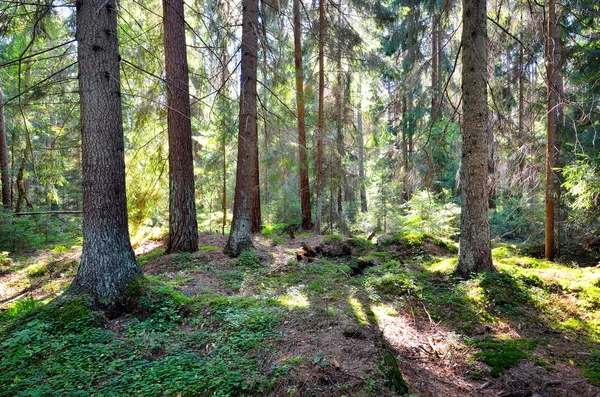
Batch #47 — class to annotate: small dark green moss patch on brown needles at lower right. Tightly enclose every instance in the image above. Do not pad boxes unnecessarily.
[471,338,538,377]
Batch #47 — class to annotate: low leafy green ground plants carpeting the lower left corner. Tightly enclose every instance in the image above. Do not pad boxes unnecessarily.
[0,285,284,397]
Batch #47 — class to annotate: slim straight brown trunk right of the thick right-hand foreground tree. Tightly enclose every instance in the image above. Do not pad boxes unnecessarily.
[545,0,558,260]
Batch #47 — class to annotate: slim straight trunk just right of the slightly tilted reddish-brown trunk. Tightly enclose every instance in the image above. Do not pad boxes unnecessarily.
[315,0,325,234]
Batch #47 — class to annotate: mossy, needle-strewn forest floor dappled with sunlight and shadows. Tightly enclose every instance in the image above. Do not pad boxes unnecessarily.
[0,232,600,397]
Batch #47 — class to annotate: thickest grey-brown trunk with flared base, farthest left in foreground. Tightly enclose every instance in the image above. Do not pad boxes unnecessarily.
[71,0,141,302]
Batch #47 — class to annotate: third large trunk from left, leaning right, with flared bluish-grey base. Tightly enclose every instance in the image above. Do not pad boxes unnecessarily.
[225,0,259,256]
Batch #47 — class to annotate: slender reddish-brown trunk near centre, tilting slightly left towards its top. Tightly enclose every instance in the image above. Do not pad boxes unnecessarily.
[293,0,313,230]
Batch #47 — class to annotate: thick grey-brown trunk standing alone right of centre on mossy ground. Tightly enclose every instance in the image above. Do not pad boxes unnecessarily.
[456,0,494,277]
